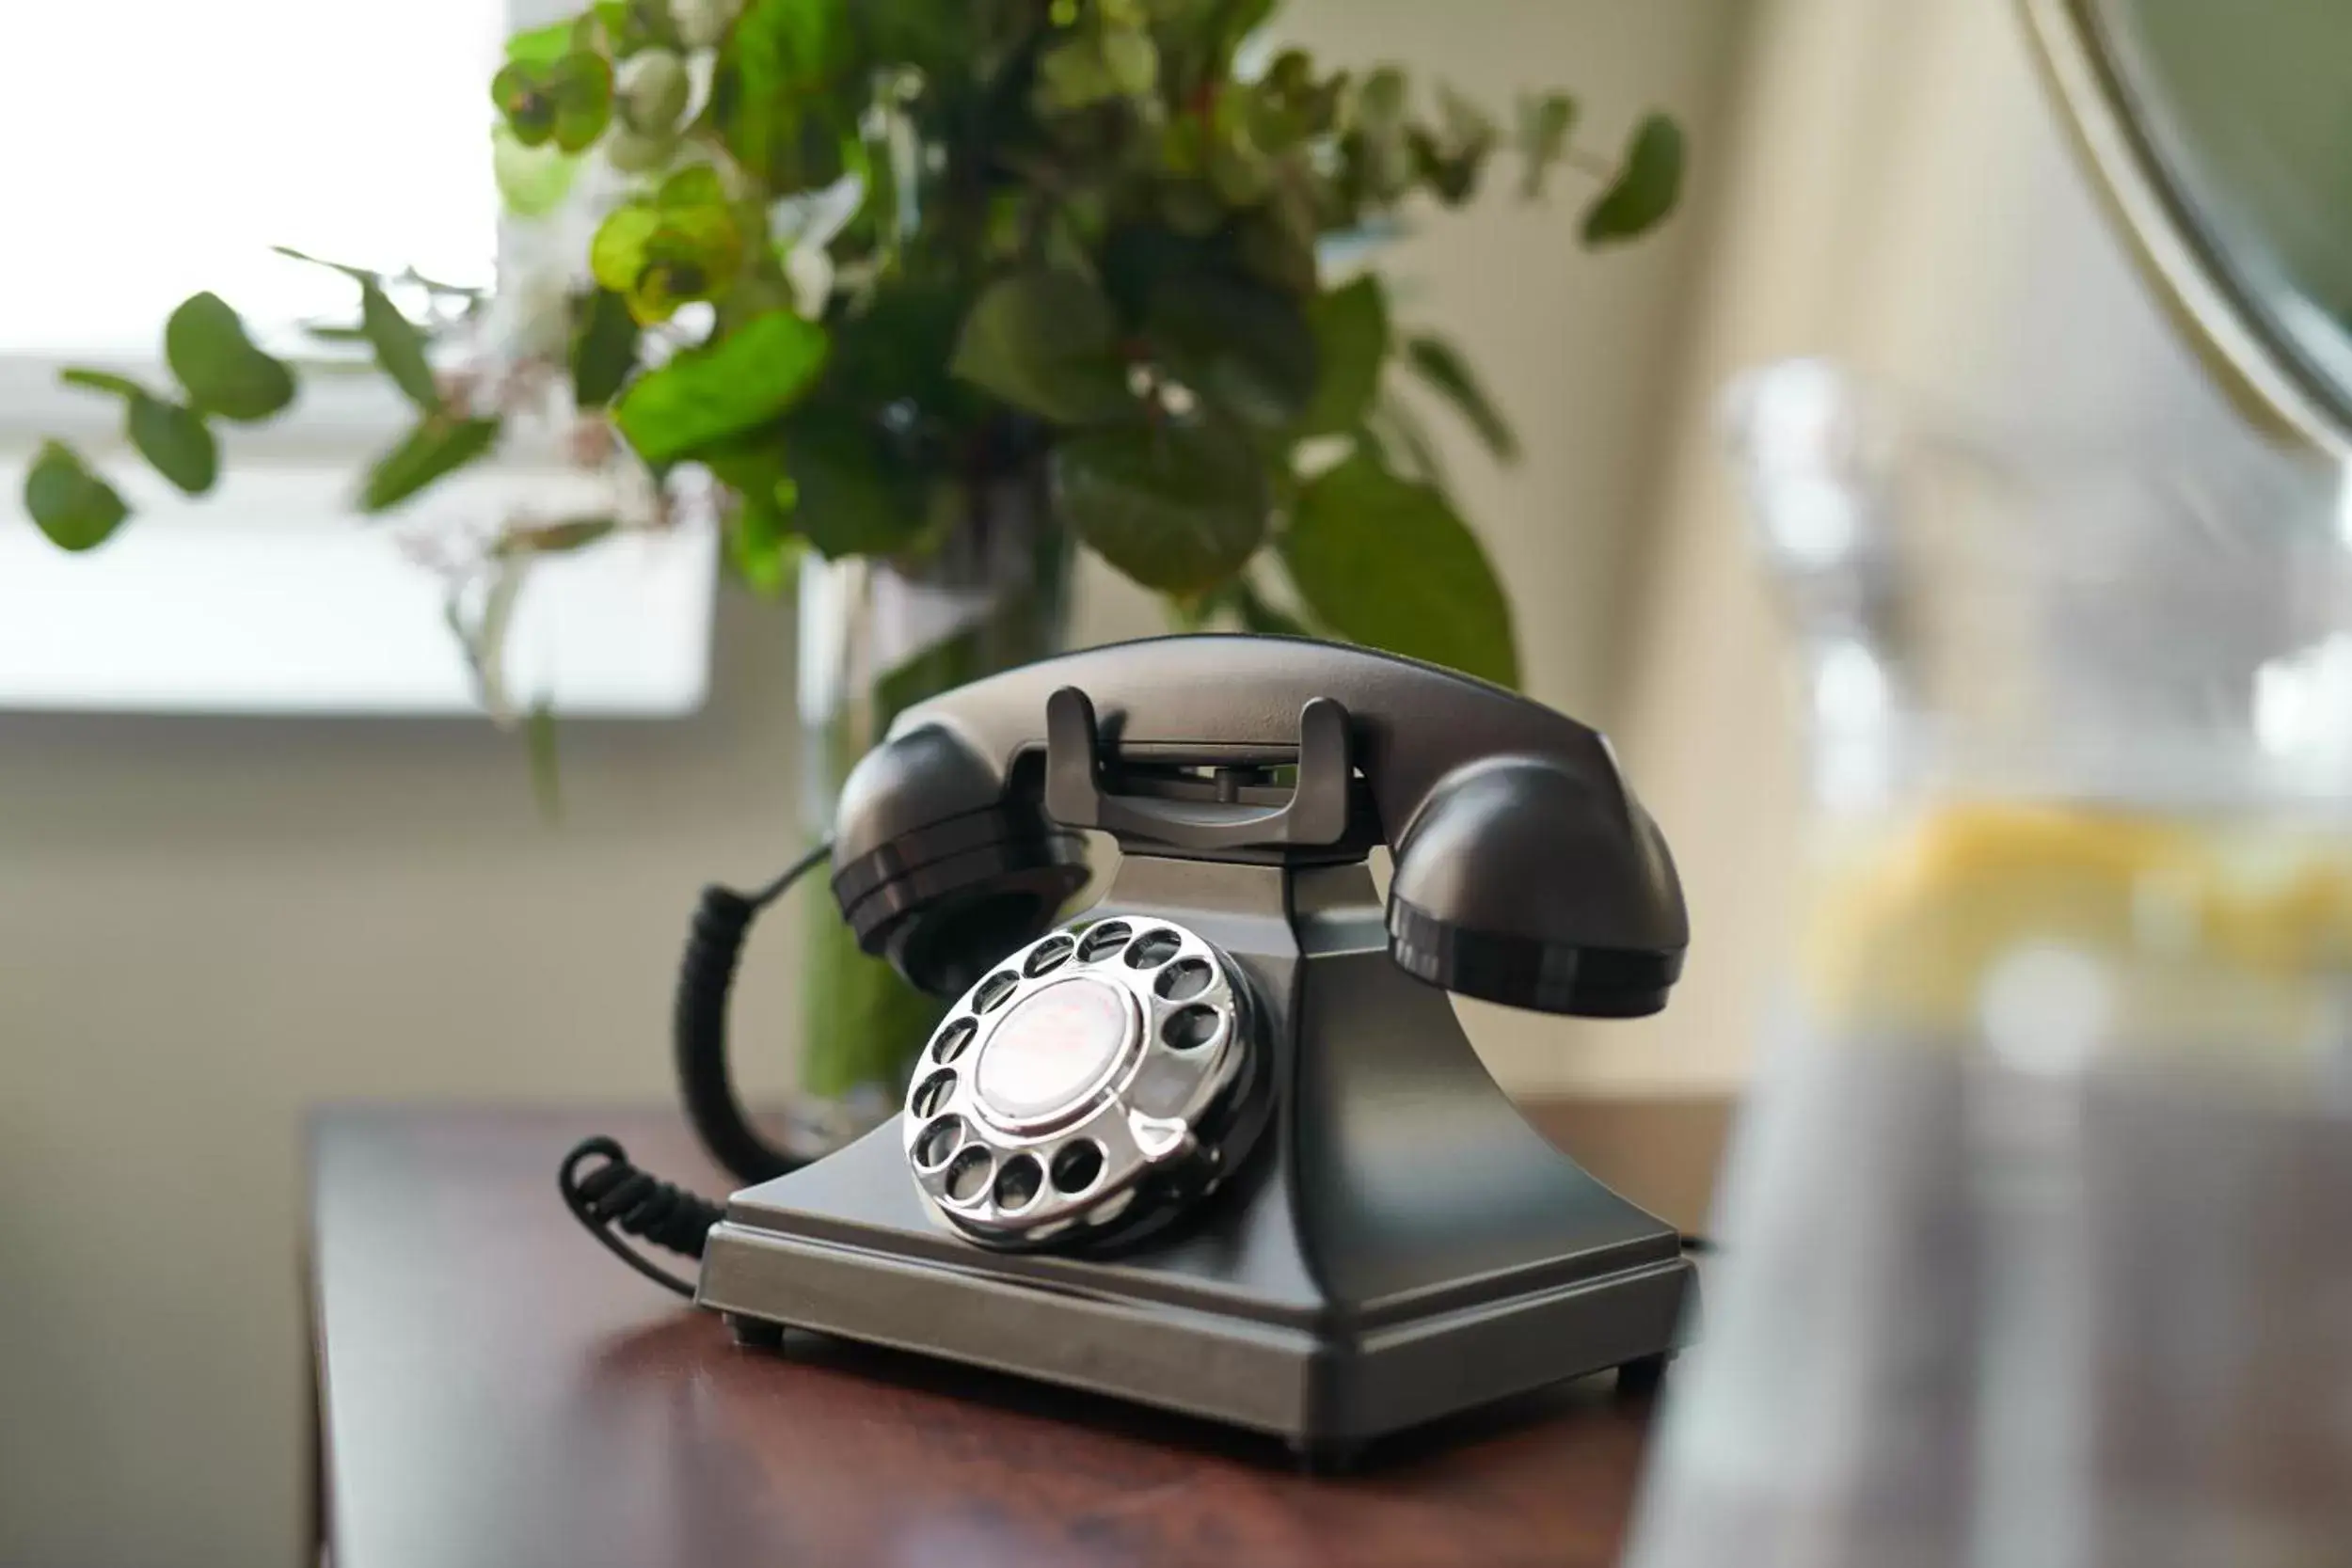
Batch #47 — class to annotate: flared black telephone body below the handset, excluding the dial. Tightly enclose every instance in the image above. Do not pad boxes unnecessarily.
[699,853,1696,1455]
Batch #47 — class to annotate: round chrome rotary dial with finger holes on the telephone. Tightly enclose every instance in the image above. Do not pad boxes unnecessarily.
[906,917,1254,1246]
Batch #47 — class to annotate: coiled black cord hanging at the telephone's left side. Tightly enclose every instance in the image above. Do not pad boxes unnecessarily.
[555,842,833,1300]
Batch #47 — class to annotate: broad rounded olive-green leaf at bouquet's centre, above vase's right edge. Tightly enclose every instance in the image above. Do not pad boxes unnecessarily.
[953,270,1136,425]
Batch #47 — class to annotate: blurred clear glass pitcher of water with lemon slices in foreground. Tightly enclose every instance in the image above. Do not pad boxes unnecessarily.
[1628,362,2352,1568]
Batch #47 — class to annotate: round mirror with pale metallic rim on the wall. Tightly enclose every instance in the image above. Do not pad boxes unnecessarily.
[2023,0,2352,453]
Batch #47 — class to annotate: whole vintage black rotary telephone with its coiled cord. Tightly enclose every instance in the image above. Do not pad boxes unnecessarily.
[564,635,1692,1460]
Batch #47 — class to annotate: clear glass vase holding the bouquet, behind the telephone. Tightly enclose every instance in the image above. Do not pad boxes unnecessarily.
[798,470,1073,1143]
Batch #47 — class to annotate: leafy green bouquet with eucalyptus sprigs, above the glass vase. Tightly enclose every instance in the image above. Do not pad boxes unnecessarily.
[24,0,1684,682]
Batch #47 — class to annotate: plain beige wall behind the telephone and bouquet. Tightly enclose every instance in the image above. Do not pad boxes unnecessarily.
[0,0,1743,1568]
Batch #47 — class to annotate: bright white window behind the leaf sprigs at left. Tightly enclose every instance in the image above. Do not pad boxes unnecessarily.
[0,0,715,715]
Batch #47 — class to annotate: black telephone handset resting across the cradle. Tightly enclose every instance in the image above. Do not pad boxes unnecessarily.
[833,637,1689,1016]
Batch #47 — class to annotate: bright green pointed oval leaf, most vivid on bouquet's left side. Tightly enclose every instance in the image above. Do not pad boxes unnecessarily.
[614,310,828,466]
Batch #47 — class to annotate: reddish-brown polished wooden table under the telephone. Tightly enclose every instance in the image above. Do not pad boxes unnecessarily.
[310,1102,1724,1568]
